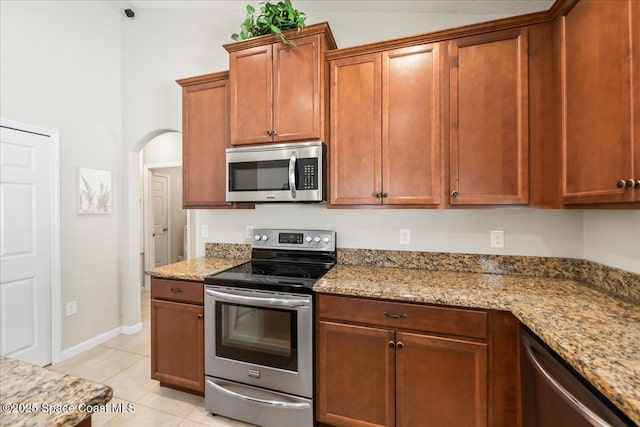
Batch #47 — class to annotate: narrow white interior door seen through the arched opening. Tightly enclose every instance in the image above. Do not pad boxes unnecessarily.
[151,174,169,267]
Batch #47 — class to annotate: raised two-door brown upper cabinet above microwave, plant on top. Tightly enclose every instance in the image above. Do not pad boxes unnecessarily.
[224,23,336,145]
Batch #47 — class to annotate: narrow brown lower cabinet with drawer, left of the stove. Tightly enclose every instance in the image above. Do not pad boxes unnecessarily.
[151,277,204,394]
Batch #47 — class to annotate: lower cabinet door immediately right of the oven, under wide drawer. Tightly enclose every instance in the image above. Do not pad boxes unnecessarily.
[316,321,395,427]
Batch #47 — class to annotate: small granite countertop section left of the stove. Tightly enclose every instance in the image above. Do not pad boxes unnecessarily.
[148,257,249,282]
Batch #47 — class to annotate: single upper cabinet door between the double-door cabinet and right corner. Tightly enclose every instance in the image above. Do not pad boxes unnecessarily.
[449,29,529,205]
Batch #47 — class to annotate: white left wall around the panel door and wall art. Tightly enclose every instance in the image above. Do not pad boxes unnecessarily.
[0,0,123,350]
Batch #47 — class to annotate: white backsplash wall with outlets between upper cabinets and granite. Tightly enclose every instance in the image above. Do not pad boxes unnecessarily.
[196,204,582,258]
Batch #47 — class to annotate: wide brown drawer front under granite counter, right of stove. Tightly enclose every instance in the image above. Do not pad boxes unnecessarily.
[318,295,487,339]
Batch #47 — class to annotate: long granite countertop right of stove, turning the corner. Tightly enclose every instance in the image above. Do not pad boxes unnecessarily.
[313,265,640,423]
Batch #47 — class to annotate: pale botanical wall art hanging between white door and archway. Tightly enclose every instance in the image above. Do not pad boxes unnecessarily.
[77,168,113,215]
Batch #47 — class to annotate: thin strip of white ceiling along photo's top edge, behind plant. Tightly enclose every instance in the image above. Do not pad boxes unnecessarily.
[126,0,553,15]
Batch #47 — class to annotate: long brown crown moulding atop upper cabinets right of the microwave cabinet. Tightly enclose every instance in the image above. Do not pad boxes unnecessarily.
[325,0,578,61]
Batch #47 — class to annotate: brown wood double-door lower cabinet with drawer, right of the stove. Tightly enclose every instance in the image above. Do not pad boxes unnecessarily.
[316,295,519,427]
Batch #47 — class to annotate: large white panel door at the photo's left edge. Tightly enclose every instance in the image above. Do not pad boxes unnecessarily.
[0,127,54,366]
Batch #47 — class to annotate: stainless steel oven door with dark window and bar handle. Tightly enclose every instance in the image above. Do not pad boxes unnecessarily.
[205,285,313,398]
